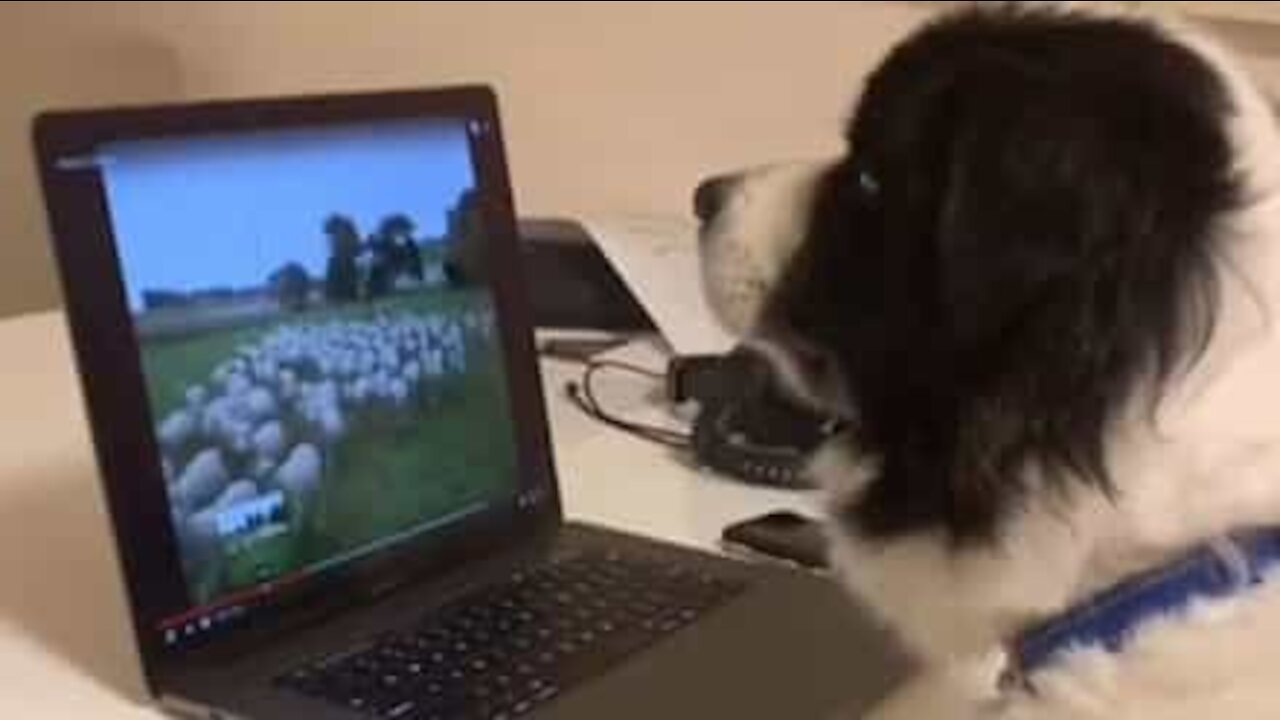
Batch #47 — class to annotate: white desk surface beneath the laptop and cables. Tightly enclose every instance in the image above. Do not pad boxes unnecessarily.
[0,313,813,720]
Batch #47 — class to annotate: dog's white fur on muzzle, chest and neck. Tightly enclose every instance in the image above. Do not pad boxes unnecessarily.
[704,7,1280,720]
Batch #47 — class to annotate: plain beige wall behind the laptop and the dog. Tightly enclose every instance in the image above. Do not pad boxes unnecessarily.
[0,3,1270,314]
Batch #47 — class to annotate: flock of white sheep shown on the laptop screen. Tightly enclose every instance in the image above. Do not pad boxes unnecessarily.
[156,304,493,561]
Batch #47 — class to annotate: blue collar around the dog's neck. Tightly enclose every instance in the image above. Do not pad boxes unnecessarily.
[1002,528,1280,685]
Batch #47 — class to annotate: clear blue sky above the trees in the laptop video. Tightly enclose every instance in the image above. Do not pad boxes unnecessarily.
[101,122,475,310]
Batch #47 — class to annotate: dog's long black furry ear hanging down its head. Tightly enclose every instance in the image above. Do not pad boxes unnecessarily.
[890,49,1234,538]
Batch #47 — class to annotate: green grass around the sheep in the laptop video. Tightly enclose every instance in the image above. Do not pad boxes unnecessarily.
[142,291,516,602]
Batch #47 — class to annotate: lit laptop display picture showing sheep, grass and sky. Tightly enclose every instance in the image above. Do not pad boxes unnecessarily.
[95,119,518,643]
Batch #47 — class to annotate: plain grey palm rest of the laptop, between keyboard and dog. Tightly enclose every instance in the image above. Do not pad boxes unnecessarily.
[535,569,913,720]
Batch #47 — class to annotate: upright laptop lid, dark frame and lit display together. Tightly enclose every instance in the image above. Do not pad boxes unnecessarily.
[36,88,559,683]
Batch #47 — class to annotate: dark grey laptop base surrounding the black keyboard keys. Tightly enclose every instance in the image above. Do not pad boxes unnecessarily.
[166,524,911,720]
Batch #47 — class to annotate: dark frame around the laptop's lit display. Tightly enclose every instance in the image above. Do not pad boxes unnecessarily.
[33,86,562,691]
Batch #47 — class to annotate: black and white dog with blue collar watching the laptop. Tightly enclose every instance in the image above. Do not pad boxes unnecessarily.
[695,4,1280,719]
